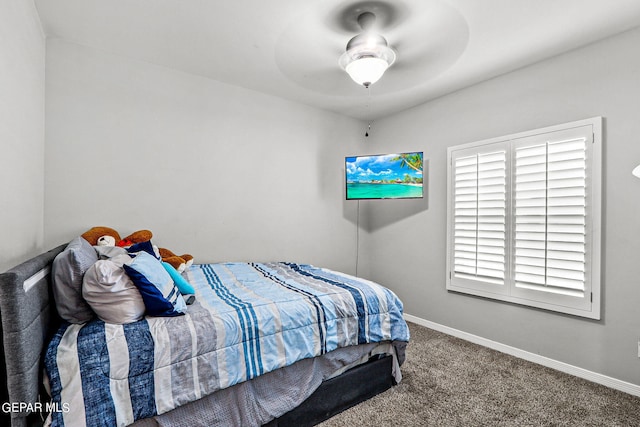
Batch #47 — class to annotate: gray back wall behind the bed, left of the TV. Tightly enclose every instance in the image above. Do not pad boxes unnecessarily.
[45,40,362,272]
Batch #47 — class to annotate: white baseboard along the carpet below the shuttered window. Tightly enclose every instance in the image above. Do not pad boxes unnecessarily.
[404,314,640,397]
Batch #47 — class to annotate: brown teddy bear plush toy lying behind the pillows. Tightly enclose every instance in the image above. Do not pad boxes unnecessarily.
[81,227,193,273]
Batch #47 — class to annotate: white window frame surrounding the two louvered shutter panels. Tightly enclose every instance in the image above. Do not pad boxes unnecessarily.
[446,117,602,320]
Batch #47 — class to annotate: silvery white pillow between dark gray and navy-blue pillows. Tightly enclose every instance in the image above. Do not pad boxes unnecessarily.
[82,255,145,324]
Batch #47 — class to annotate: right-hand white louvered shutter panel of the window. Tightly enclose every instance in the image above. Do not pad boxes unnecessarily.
[514,138,587,297]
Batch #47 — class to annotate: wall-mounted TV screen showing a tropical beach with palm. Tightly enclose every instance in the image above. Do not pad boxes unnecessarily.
[345,152,423,200]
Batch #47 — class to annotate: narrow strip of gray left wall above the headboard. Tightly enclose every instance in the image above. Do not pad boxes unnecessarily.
[0,0,45,272]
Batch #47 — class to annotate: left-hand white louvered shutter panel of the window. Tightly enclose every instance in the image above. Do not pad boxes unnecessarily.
[453,151,507,284]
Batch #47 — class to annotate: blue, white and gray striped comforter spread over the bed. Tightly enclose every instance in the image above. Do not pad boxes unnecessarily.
[45,263,409,427]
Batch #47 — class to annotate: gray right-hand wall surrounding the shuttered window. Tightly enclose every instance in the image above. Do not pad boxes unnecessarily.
[361,30,640,384]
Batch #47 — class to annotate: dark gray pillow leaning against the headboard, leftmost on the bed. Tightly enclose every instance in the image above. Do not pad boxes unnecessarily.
[52,236,98,324]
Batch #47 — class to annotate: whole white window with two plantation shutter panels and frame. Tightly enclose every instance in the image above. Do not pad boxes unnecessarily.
[447,118,602,319]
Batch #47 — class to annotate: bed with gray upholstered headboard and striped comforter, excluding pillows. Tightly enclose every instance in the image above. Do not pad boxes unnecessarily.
[0,241,409,427]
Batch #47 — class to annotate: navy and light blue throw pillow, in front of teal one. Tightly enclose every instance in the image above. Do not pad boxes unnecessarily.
[124,251,187,316]
